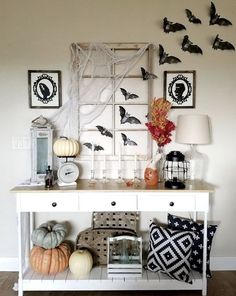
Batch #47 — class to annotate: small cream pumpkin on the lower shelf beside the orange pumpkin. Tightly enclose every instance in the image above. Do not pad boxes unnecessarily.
[69,249,93,279]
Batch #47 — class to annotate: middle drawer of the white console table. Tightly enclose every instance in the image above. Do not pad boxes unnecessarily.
[79,193,137,212]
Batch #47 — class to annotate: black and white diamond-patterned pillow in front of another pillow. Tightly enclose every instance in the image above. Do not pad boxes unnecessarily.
[147,222,195,283]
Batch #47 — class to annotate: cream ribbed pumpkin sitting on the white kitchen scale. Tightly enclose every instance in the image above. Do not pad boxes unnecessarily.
[53,137,79,157]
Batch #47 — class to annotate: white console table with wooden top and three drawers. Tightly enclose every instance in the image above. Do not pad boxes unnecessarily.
[12,180,213,296]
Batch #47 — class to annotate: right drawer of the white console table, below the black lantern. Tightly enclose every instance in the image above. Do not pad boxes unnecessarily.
[138,194,196,212]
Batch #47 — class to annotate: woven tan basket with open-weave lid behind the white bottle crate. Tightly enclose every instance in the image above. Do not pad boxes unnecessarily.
[76,212,137,265]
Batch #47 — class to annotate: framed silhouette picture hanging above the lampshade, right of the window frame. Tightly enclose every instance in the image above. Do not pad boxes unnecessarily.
[164,70,196,108]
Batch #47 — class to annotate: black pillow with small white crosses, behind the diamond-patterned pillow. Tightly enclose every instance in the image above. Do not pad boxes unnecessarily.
[168,214,217,277]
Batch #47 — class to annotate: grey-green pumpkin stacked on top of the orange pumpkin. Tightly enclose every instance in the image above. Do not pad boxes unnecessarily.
[31,222,67,249]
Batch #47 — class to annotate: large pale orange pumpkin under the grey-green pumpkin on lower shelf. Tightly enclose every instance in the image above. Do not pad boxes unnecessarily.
[30,243,71,275]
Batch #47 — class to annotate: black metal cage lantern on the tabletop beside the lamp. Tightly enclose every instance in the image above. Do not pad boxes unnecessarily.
[164,151,188,189]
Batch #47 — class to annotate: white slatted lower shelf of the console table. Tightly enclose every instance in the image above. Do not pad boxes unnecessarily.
[23,266,203,291]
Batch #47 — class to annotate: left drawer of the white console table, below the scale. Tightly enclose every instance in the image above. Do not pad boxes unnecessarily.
[18,193,79,212]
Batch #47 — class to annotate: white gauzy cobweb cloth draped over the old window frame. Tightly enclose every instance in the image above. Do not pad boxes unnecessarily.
[50,43,150,139]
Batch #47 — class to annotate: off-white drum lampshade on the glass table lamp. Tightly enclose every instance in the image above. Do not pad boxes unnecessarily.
[175,114,210,144]
